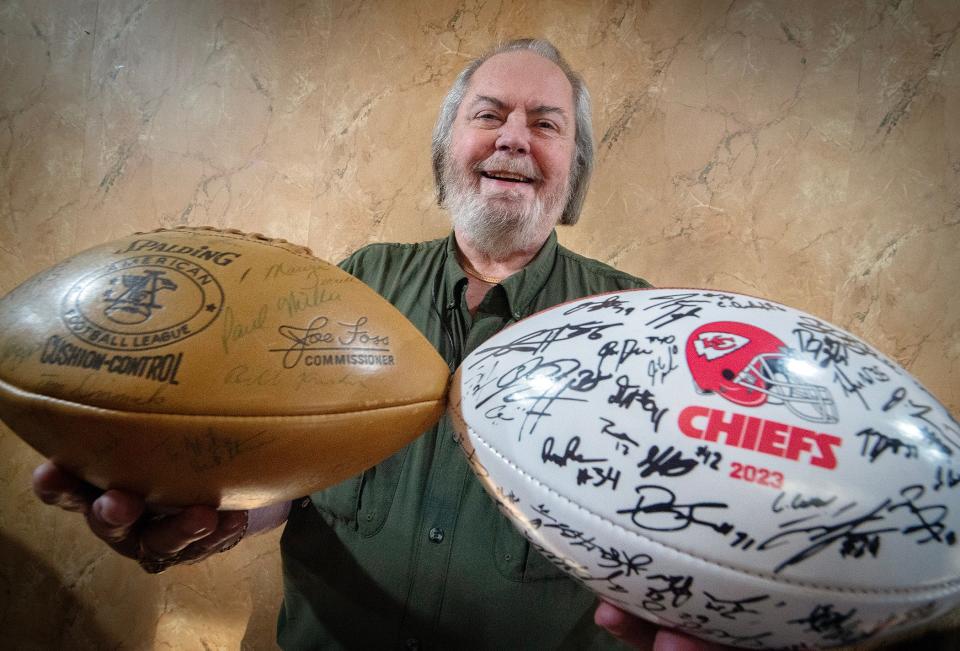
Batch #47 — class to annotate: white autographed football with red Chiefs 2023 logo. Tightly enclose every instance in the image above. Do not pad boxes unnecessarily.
[450,289,960,648]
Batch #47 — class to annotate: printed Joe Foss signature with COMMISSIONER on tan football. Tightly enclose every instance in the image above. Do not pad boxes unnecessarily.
[270,316,390,368]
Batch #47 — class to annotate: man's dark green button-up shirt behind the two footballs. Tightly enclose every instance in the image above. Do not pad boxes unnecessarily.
[278,233,648,649]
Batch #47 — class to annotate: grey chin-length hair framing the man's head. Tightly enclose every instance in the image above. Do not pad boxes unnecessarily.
[432,38,593,224]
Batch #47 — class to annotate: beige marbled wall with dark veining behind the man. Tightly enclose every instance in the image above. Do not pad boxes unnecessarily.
[0,0,960,649]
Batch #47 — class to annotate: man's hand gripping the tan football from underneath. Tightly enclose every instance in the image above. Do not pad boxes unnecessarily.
[33,461,249,573]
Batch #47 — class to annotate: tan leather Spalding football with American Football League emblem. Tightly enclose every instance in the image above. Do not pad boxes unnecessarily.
[0,228,449,509]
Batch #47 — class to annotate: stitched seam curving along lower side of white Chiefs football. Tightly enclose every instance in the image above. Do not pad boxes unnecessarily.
[460,422,960,598]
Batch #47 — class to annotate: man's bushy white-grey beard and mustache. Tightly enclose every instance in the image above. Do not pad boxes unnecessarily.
[444,157,568,259]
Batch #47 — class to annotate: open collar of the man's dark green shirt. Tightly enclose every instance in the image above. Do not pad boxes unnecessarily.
[444,230,558,319]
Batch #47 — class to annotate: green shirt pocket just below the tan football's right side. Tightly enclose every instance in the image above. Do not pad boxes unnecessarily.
[310,447,408,538]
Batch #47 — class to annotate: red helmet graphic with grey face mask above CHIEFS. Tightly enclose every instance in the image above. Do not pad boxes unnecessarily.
[687,321,838,423]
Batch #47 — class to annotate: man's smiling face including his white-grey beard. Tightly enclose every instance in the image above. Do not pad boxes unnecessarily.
[444,51,575,253]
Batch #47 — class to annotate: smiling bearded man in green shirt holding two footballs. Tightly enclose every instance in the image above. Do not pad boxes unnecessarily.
[34,40,728,649]
